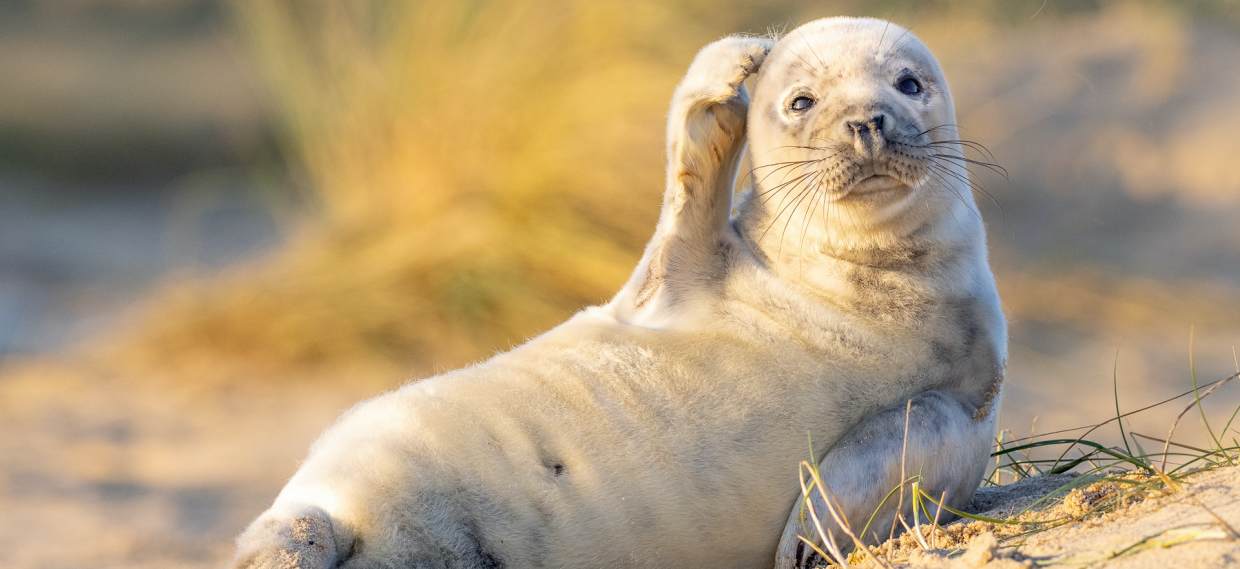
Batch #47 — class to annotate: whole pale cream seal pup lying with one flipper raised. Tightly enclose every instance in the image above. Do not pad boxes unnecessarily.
[234,19,1006,569]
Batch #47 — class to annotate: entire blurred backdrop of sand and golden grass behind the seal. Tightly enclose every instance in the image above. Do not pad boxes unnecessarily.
[0,0,1240,569]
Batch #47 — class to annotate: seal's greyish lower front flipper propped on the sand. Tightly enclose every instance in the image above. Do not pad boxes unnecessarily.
[775,392,994,569]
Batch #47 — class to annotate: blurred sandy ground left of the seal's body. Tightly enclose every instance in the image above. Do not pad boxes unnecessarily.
[0,362,381,569]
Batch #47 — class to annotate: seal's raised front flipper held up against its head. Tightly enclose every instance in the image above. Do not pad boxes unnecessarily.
[611,37,771,326]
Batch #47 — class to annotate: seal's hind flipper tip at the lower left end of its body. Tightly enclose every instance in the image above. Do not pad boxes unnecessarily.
[232,506,348,569]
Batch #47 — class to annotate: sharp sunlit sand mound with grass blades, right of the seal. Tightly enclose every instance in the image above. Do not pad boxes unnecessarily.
[887,466,1240,569]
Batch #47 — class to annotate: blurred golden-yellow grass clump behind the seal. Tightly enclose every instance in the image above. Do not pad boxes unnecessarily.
[109,0,1236,384]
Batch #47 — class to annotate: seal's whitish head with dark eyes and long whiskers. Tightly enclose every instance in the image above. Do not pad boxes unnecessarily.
[749,19,963,235]
